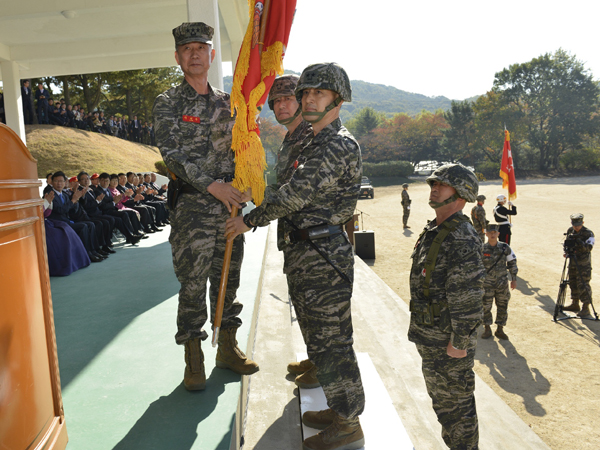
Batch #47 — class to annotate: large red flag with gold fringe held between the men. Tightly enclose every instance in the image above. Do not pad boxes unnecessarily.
[231,0,296,205]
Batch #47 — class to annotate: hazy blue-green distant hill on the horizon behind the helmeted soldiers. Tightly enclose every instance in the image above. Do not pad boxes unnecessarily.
[223,76,451,122]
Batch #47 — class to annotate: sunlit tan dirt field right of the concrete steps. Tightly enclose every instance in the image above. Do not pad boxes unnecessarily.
[357,177,600,450]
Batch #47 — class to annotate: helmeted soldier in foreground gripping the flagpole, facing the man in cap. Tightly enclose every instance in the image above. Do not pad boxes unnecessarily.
[227,63,365,450]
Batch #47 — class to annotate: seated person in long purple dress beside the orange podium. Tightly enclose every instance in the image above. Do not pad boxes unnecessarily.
[44,190,90,277]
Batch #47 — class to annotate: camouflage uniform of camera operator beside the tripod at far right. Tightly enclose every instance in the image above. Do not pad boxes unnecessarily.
[567,226,595,303]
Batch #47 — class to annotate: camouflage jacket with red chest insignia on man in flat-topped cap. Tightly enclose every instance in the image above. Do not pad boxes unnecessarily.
[153,80,235,214]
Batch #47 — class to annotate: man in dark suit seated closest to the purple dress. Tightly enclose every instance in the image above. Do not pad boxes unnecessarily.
[49,171,104,262]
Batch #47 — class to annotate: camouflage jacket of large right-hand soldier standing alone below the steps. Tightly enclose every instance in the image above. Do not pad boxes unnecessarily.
[408,211,485,350]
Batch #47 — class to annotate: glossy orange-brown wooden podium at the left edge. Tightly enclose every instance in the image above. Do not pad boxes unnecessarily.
[0,124,67,450]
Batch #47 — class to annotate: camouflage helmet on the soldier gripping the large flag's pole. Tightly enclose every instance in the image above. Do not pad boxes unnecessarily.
[296,63,352,103]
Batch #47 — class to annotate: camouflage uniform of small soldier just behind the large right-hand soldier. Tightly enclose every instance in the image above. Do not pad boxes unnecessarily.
[483,242,519,326]
